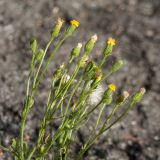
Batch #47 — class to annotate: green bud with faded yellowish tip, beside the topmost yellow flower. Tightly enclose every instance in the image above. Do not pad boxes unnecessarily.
[51,18,64,38]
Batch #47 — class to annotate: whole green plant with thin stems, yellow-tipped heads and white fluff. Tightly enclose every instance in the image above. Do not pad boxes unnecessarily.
[0,18,145,160]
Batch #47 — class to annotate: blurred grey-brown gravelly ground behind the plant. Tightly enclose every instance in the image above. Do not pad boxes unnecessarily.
[0,0,160,160]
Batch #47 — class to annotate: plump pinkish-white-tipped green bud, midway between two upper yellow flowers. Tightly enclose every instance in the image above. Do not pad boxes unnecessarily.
[84,34,98,54]
